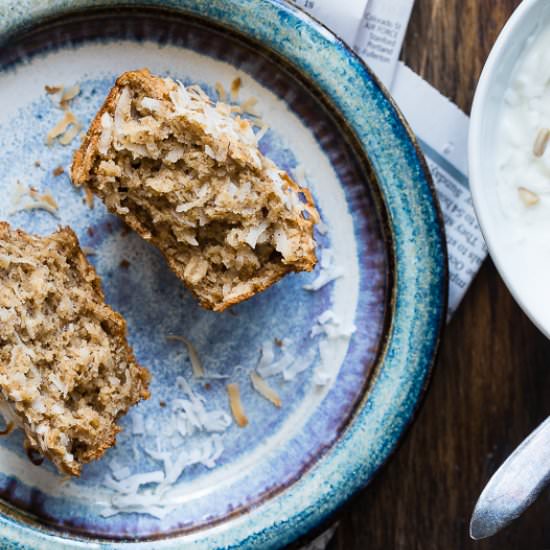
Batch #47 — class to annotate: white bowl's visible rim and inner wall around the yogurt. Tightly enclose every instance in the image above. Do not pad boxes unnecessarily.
[469,0,550,337]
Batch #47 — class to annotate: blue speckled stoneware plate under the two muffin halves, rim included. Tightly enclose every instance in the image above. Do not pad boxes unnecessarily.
[0,0,447,550]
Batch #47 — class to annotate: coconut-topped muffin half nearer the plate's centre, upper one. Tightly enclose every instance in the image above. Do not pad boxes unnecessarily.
[72,70,318,311]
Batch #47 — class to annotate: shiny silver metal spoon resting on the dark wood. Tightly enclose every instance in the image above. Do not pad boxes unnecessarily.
[470,418,550,540]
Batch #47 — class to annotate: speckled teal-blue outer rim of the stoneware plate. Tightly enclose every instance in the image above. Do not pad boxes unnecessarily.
[0,0,448,549]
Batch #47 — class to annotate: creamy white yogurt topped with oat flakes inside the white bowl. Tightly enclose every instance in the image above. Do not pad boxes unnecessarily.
[493,23,550,327]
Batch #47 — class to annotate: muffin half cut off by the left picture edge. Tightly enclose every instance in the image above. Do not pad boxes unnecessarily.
[0,222,149,475]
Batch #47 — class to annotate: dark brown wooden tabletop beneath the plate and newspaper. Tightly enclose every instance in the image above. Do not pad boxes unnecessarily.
[330,0,550,550]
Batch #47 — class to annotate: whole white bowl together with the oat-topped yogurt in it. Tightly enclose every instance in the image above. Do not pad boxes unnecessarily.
[469,0,550,337]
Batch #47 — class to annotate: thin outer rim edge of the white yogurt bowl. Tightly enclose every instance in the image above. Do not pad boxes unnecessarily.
[468,0,550,338]
